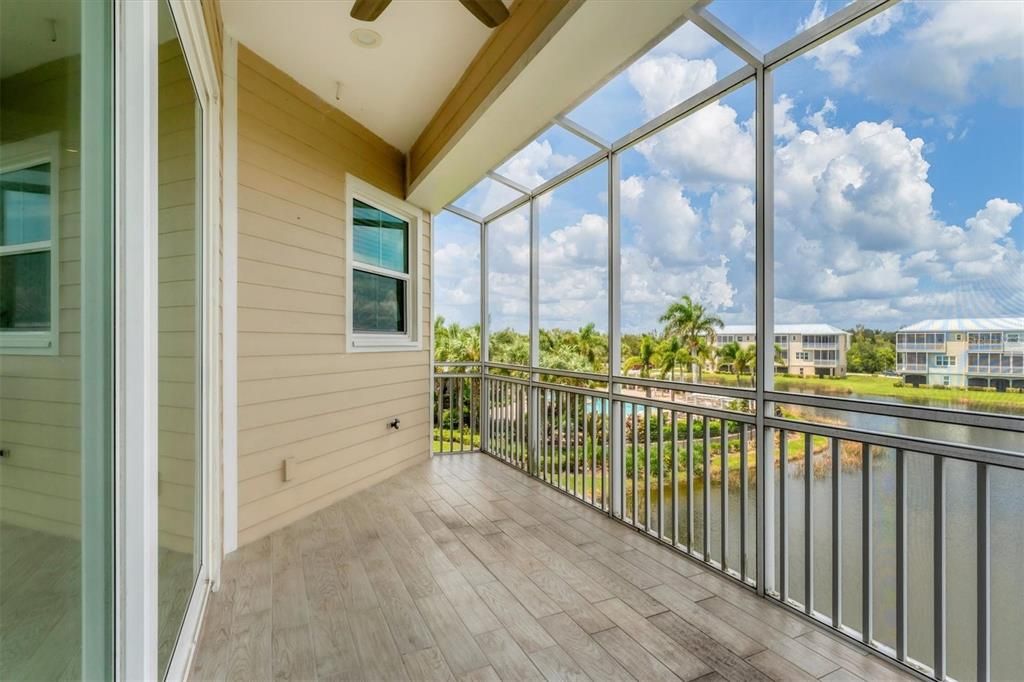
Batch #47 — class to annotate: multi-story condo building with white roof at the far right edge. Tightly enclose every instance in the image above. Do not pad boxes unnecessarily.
[896,317,1024,390]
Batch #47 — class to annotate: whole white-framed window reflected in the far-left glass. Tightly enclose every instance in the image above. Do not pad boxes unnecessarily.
[0,133,59,354]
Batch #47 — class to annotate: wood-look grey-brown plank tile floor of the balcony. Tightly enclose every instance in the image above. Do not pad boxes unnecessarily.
[193,454,910,680]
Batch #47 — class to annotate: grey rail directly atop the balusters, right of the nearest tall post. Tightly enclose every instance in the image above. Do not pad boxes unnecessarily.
[765,417,1024,470]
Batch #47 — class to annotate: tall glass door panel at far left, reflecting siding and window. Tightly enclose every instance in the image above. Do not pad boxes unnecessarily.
[0,0,116,680]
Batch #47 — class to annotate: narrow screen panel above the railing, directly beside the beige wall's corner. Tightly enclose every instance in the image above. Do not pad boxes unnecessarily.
[431,211,480,363]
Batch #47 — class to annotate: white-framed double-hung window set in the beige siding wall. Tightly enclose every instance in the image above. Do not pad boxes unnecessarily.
[346,176,420,350]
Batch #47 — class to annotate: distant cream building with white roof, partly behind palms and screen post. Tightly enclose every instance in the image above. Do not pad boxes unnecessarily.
[715,325,850,377]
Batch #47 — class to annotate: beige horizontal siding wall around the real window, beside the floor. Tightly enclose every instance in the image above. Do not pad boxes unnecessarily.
[238,46,430,544]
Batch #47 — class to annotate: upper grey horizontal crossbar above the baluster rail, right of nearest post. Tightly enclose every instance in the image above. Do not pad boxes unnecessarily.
[765,391,1024,433]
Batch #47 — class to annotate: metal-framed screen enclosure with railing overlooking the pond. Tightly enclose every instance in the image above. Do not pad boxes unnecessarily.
[433,1,1024,679]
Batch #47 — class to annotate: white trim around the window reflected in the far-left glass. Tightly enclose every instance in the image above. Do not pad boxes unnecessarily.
[0,132,60,355]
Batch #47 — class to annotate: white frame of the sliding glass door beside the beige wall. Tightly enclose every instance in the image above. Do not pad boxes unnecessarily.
[113,0,222,680]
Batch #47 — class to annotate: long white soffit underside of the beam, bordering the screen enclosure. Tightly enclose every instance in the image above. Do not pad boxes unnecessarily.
[408,0,695,212]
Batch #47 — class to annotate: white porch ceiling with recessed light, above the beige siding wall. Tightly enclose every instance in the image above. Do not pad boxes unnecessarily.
[221,0,508,152]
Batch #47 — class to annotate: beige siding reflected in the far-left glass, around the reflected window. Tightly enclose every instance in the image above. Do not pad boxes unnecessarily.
[0,57,82,538]
